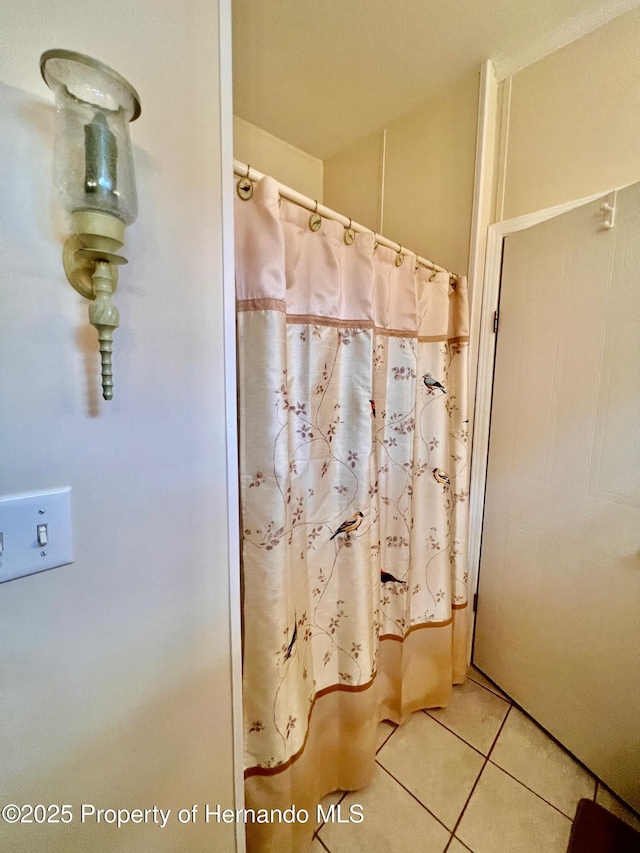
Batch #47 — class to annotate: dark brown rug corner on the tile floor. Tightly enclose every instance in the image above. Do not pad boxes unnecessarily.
[567,800,640,853]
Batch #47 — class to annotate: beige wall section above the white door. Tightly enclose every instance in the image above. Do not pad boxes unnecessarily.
[498,9,640,219]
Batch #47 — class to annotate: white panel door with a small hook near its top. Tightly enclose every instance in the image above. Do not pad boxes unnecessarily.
[473,184,640,809]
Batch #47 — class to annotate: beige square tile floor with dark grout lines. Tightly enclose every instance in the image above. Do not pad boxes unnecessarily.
[311,668,640,853]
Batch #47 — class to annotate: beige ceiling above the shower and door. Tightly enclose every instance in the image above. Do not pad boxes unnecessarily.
[233,0,640,159]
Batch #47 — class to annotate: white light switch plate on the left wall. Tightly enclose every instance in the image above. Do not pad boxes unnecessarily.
[0,488,73,583]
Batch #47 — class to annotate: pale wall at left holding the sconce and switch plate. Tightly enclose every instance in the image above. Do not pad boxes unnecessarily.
[0,0,237,853]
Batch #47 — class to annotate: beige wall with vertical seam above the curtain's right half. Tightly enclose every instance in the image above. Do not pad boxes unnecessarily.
[324,72,479,274]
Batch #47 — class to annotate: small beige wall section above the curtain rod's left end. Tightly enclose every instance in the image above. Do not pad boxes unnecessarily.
[233,116,323,202]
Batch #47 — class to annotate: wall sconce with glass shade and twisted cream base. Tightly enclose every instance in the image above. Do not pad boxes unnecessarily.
[40,50,140,400]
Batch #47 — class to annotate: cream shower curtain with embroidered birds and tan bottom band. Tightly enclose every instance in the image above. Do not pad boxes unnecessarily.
[236,178,469,853]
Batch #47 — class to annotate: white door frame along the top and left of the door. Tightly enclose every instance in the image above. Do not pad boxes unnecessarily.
[468,184,631,663]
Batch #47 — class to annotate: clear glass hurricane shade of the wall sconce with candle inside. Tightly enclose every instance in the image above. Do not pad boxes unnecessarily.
[40,50,140,225]
